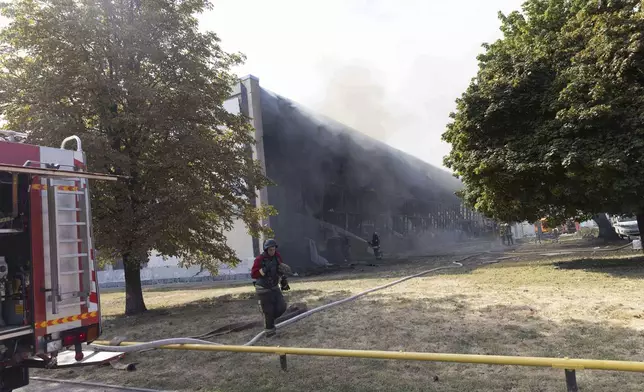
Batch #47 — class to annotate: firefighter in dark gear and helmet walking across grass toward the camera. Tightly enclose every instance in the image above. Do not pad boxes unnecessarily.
[250,239,290,337]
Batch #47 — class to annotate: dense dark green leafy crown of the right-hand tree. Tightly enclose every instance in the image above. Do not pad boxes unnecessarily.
[443,0,644,239]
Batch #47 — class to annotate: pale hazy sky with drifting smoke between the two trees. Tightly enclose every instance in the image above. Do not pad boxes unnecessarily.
[200,0,523,166]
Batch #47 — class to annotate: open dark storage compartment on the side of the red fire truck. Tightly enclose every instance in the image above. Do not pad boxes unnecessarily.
[0,171,33,339]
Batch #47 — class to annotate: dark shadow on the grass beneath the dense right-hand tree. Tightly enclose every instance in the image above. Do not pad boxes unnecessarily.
[553,256,644,278]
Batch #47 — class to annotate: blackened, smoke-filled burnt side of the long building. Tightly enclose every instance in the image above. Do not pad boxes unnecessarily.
[261,89,487,270]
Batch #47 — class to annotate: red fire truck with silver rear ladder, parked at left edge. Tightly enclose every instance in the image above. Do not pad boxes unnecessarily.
[0,131,117,392]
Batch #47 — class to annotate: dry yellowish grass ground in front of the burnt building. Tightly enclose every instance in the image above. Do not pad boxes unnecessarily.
[38,240,644,392]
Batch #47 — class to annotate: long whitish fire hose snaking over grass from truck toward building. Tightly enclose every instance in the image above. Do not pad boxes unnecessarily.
[90,252,478,353]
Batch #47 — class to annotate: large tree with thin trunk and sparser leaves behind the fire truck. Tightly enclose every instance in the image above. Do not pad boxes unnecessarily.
[0,0,270,314]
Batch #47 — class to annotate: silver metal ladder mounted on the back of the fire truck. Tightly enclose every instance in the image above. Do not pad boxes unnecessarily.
[47,173,92,314]
